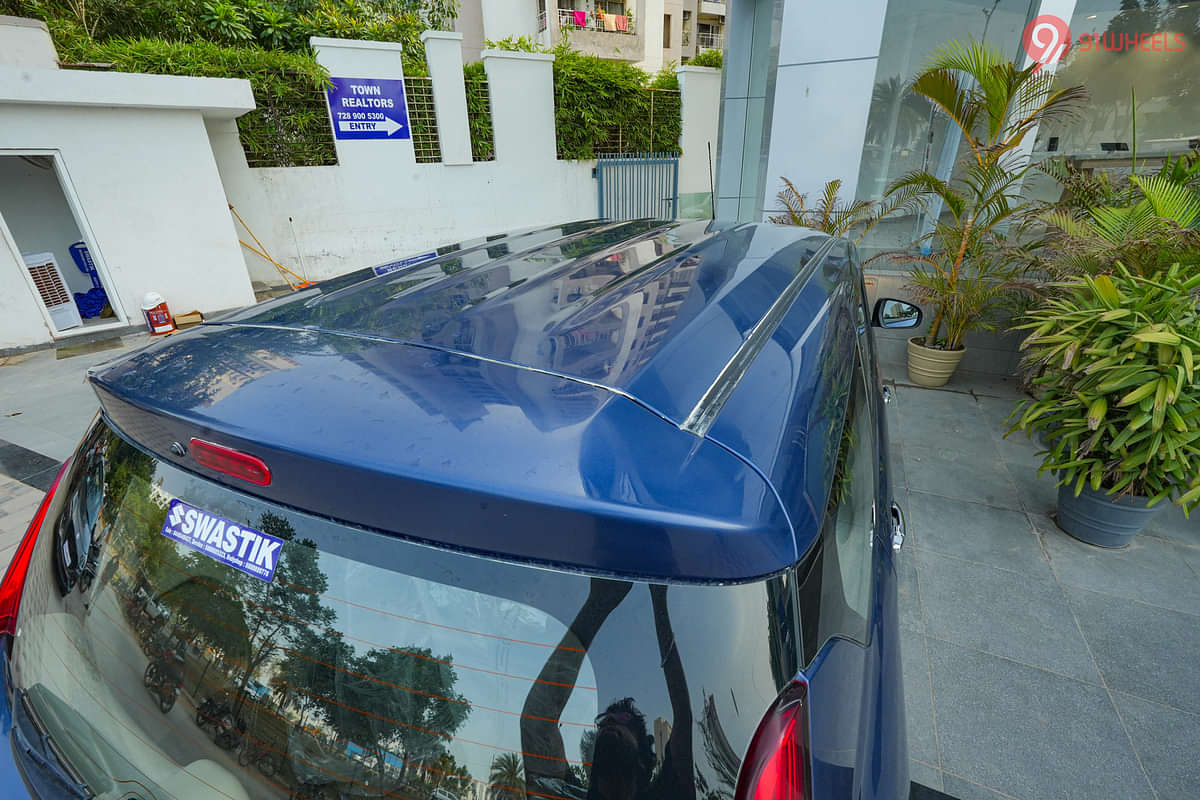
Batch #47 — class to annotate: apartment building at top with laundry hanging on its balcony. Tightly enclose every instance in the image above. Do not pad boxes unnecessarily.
[456,0,725,72]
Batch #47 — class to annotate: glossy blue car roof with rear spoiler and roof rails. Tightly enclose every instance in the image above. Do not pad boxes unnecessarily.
[91,221,858,582]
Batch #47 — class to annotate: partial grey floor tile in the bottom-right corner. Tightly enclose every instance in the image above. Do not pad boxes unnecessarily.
[1114,692,1200,800]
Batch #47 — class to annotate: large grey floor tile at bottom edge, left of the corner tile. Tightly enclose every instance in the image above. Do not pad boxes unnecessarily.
[930,643,1153,800]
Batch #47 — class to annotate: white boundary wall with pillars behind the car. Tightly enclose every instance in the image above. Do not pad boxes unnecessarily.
[209,37,720,283]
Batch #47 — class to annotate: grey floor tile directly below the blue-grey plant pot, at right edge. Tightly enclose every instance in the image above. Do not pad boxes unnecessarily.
[1043,530,1200,614]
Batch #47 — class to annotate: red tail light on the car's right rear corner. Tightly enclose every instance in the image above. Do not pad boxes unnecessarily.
[736,680,812,800]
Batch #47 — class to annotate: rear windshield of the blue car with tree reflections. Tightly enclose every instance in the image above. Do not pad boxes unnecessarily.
[11,421,797,800]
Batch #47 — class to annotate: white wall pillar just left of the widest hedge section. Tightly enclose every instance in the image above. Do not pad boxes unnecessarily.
[482,50,558,163]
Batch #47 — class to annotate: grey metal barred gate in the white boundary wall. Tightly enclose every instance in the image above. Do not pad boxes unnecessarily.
[596,152,679,219]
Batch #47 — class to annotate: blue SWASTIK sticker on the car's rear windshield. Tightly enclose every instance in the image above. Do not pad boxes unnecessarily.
[162,500,283,583]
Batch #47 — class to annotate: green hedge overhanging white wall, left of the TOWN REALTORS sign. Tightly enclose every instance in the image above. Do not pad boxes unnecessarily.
[55,30,337,167]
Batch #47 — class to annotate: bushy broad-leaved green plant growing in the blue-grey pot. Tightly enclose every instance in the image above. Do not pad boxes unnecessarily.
[1008,264,1200,511]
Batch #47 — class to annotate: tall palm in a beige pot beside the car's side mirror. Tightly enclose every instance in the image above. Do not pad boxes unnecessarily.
[887,42,1085,386]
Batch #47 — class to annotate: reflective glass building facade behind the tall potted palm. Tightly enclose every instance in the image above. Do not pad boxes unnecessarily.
[857,0,1200,260]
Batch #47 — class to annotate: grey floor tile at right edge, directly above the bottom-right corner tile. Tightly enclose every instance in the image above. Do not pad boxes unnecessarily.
[1067,587,1200,714]
